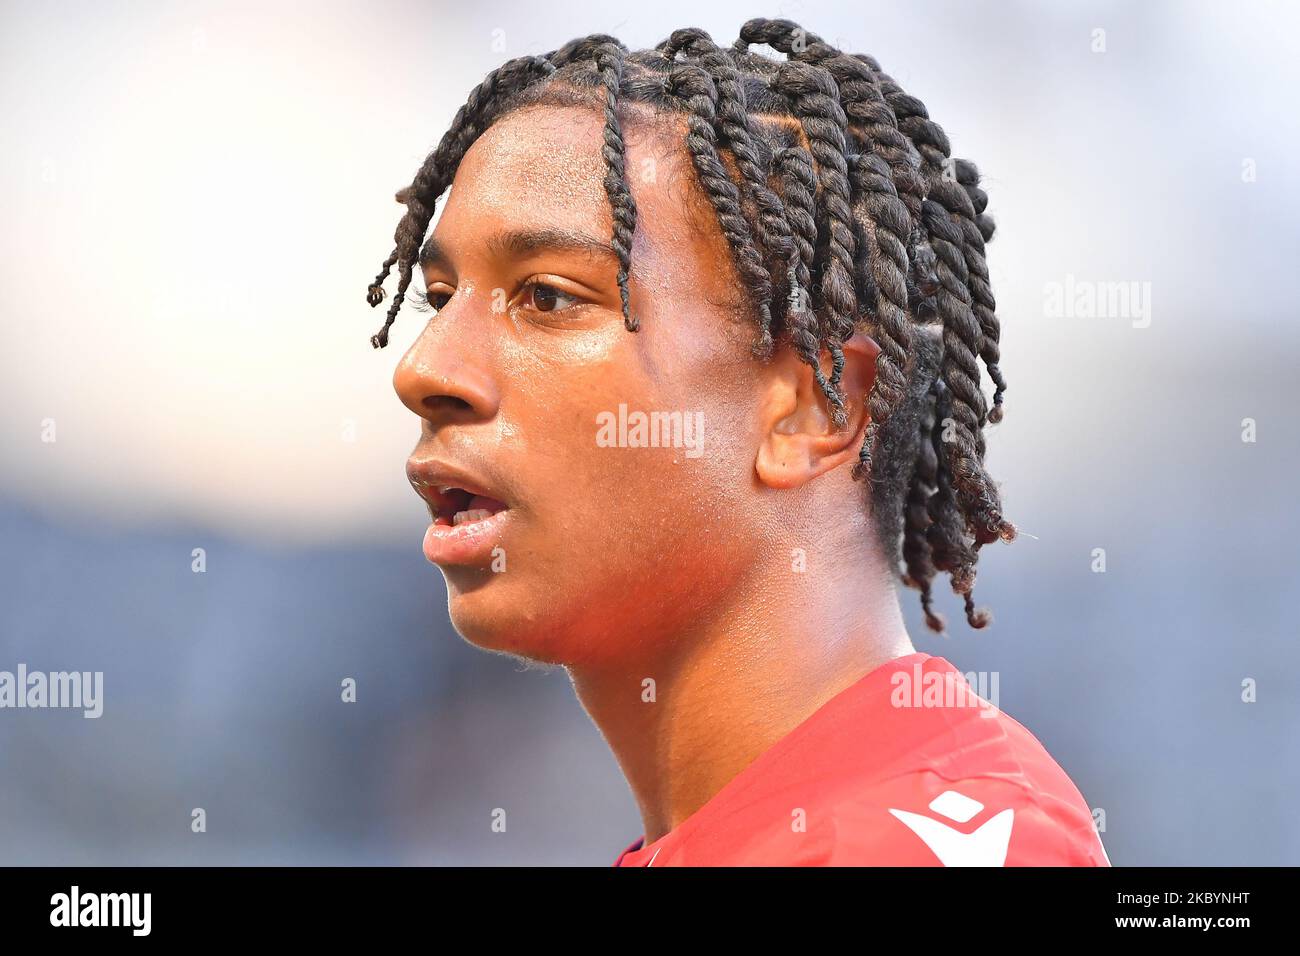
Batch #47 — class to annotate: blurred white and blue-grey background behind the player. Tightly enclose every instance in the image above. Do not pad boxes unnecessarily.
[0,0,1300,865]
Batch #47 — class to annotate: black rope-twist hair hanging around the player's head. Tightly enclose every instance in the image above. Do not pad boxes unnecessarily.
[367,18,1015,631]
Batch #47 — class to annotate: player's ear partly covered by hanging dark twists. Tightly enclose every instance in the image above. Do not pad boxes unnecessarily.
[754,332,880,488]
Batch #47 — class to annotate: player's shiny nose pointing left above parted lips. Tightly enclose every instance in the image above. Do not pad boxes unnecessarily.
[393,306,501,428]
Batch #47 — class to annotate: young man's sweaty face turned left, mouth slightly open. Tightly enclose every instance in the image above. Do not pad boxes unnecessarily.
[394,107,780,665]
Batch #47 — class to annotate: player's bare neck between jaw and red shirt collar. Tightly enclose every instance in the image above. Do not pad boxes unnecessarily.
[569,549,914,844]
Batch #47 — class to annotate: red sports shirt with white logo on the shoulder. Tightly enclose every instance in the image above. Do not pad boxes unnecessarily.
[614,654,1110,866]
